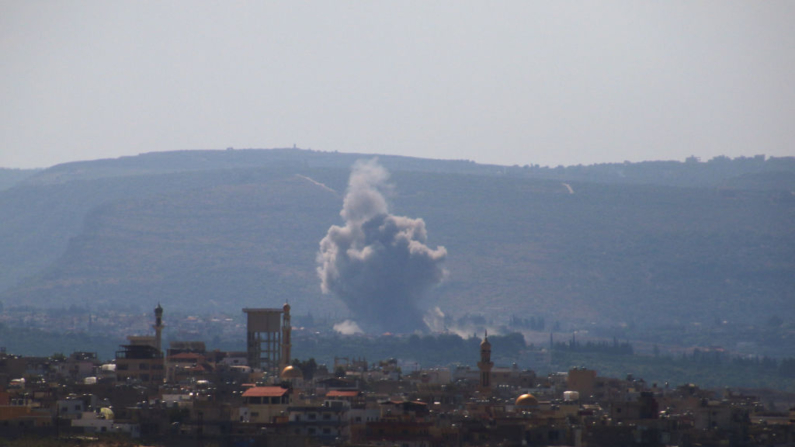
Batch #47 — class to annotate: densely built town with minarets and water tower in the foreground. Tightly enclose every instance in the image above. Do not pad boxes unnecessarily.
[0,304,795,447]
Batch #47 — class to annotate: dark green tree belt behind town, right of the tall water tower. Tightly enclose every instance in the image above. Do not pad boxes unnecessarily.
[295,333,795,391]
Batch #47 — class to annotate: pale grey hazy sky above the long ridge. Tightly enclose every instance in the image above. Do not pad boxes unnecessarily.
[0,0,795,167]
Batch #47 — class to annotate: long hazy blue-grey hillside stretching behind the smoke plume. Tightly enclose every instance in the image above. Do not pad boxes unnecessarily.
[0,150,795,340]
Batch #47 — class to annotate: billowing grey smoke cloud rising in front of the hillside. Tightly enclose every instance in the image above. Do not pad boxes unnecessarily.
[317,160,447,332]
